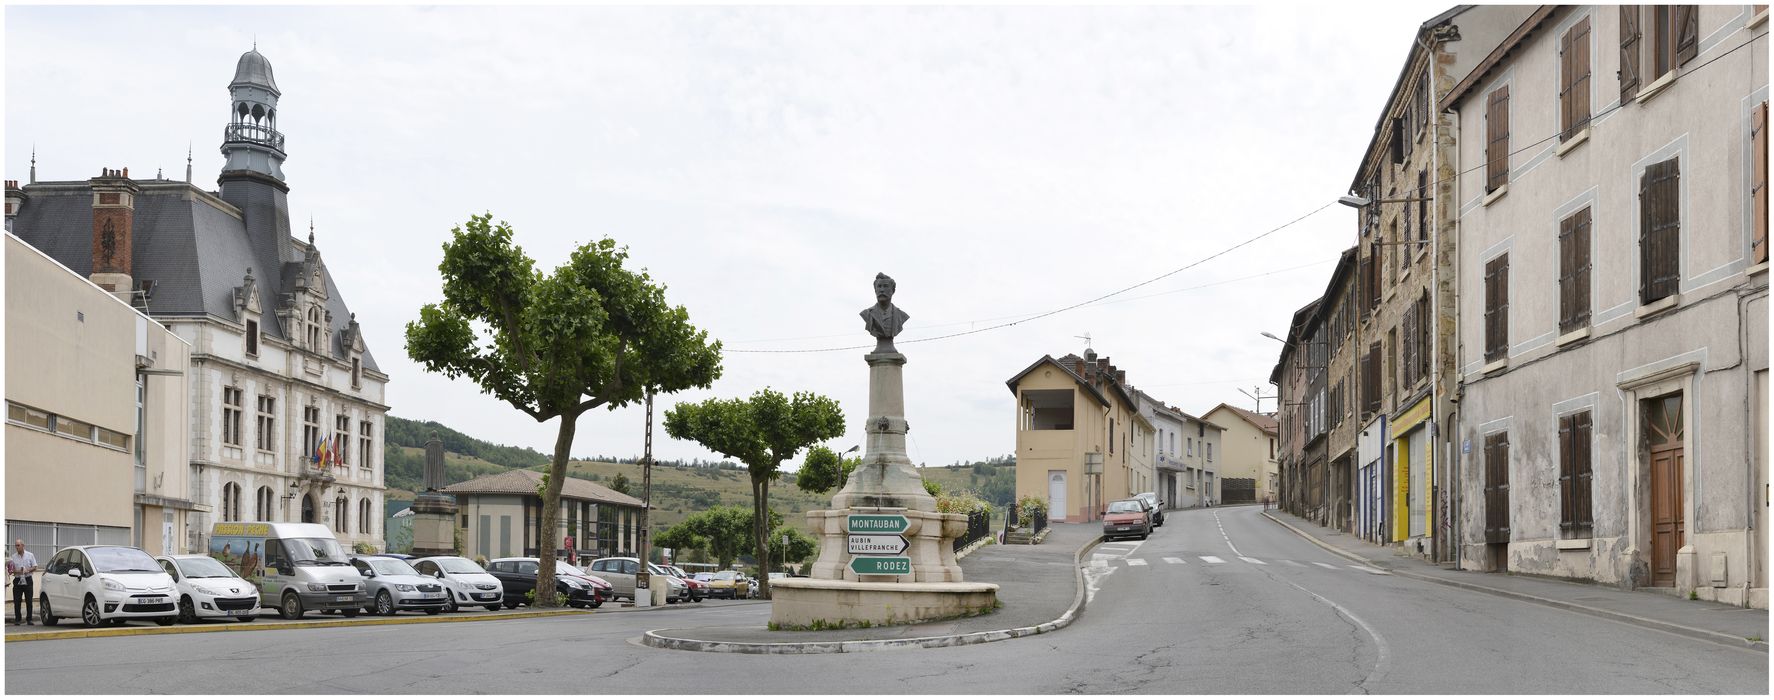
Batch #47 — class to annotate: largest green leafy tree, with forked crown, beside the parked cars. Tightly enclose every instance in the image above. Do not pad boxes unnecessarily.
[406,214,720,609]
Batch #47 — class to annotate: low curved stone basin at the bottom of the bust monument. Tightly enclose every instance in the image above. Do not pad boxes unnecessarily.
[770,578,997,627]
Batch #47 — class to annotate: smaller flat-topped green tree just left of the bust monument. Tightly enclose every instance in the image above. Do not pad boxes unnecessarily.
[665,388,844,597]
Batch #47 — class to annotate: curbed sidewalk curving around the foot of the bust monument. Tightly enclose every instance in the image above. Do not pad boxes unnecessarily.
[644,523,1102,654]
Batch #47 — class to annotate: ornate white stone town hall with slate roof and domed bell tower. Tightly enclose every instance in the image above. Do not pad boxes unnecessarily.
[5,50,389,551]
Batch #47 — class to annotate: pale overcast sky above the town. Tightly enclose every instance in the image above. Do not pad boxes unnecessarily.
[5,5,1446,466]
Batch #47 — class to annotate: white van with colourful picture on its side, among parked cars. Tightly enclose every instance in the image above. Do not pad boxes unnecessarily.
[209,523,369,620]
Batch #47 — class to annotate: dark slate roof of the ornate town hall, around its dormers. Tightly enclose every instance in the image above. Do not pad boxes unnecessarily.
[12,181,381,372]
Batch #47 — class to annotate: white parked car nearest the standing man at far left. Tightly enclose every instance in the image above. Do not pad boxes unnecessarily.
[39,544,177,627]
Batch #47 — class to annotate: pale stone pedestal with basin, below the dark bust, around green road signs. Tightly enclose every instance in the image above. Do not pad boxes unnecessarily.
[770,351,997,627]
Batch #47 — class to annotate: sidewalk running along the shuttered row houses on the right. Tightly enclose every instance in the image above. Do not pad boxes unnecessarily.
[1263,509,1769,652]
